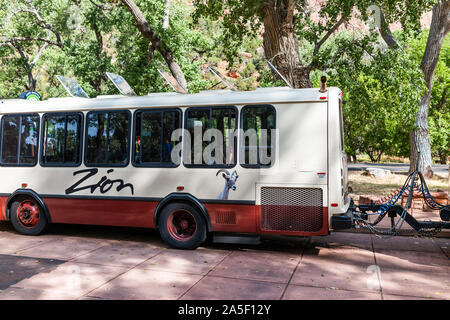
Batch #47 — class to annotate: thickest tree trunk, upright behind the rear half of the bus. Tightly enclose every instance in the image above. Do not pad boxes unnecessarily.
[263,0,312,88]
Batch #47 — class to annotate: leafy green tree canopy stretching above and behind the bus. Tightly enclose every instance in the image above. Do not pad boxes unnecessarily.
[0,0,450,162]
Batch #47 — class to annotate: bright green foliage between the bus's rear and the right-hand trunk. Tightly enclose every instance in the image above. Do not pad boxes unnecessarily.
[316,33,425,161]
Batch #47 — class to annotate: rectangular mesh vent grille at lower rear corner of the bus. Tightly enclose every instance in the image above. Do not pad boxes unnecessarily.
[261,187,323,232]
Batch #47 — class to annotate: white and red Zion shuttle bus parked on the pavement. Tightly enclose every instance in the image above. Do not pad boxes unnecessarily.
[0,87,350,249]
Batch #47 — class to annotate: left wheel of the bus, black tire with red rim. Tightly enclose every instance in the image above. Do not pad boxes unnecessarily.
[9,197,48,236]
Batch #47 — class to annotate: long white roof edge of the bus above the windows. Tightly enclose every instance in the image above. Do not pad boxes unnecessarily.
[0,87,334,114]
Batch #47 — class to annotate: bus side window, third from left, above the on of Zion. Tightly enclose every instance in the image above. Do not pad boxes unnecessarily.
[85,111,131,167]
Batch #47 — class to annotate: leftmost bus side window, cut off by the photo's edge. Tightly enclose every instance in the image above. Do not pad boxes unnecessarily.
[1,114,39,166]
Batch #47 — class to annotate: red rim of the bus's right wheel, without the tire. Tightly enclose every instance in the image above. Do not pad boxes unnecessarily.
[167,210,197,241]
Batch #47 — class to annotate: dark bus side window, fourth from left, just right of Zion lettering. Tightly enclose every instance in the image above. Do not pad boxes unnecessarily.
[134,109,181,167]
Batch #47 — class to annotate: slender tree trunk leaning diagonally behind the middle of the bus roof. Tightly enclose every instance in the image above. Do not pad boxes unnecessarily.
[121,0,187,90]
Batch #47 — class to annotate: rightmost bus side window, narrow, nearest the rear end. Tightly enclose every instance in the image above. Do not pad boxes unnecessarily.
[240,105,276,168]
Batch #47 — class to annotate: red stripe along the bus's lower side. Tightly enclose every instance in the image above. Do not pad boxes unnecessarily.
[0,197,328,236]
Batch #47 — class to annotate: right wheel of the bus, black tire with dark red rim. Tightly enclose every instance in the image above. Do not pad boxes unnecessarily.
[159,202,207,250]
